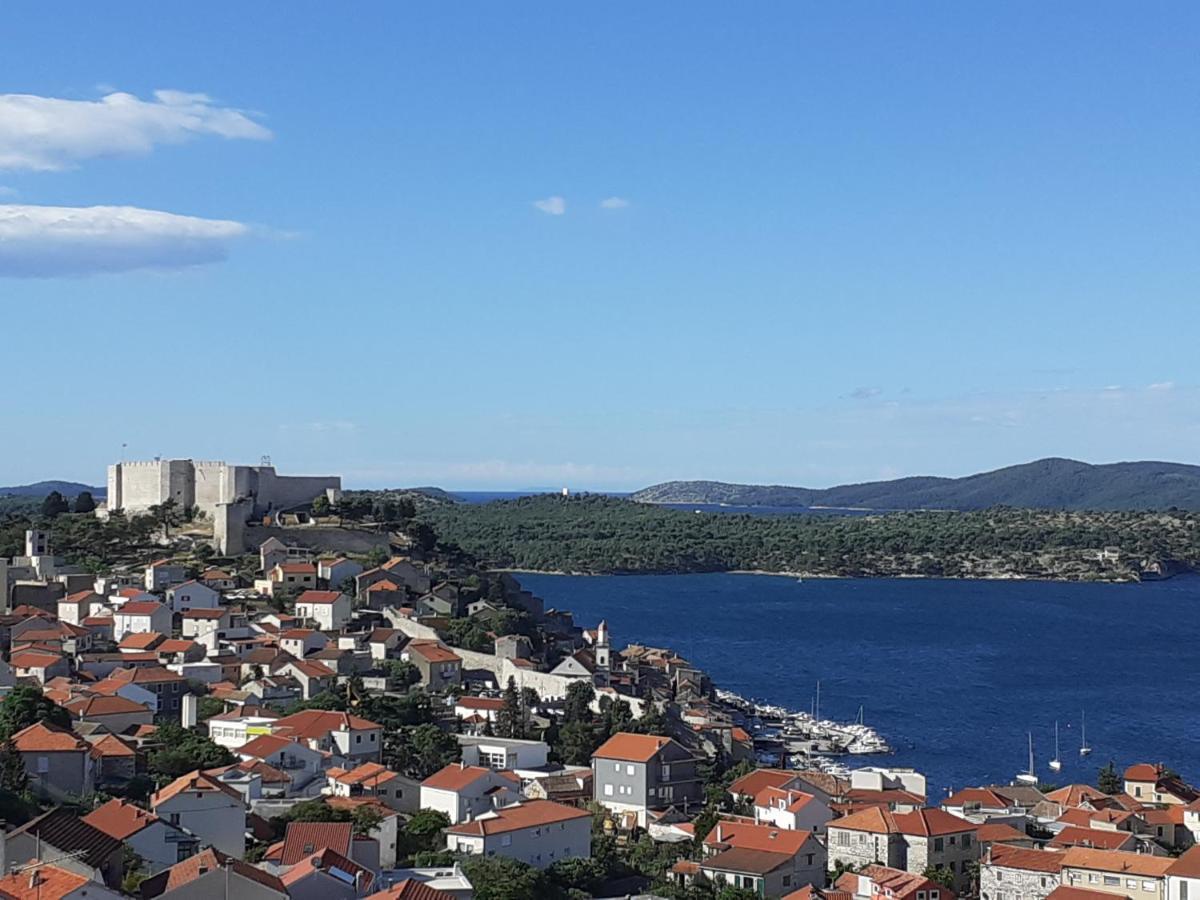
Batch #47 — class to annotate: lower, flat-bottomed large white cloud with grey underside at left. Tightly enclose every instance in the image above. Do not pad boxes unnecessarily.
[0,204,250,277]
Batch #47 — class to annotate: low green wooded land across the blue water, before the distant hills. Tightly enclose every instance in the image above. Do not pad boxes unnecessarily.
[420,494,1200,581]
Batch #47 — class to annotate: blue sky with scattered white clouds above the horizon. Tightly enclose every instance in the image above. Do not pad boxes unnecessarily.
[0,2,1200,488]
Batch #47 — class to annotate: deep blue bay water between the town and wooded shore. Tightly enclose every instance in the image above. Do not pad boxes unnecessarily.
[520,575,1200,799]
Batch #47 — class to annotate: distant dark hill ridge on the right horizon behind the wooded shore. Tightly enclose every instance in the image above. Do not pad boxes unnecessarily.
[632,458,1200,510]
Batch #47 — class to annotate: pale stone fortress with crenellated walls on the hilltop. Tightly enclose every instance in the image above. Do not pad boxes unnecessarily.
[106,460,342,552]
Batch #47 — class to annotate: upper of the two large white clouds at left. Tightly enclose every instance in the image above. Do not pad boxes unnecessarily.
[0,90,271,172]
